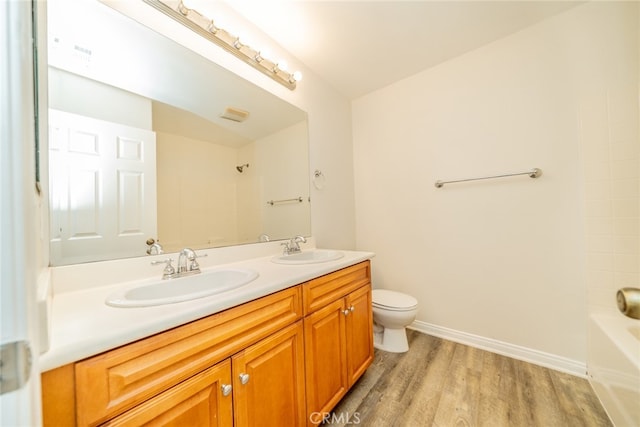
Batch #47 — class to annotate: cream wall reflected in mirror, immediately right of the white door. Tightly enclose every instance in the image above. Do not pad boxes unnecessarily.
[156,132,238,252]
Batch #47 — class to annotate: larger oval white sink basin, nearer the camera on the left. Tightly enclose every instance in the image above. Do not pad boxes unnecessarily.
[105,268,258,307]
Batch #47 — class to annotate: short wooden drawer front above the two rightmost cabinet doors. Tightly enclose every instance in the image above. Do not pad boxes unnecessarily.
[302,261,371,316]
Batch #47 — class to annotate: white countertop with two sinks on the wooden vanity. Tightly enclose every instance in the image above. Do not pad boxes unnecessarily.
[39,251,374,372]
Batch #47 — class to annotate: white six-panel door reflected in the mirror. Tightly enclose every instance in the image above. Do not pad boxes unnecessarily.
[49,109,157,264]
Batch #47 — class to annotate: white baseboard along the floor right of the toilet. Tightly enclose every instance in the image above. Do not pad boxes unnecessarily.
[408,320,587,378]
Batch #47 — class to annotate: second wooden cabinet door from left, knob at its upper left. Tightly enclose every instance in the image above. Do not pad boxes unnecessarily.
[232,321,306,427]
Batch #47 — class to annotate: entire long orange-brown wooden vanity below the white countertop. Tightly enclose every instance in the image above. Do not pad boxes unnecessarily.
[42,253,373,426]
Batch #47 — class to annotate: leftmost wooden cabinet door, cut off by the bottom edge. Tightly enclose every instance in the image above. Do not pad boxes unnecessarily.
[103,359,233,427]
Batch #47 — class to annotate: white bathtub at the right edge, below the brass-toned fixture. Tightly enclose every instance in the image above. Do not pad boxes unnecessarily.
[587,313,640,427]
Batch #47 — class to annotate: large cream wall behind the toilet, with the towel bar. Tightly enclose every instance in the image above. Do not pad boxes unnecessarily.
[353,3,637,372]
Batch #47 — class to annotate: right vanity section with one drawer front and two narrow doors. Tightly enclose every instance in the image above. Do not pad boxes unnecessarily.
[303,261,373,424]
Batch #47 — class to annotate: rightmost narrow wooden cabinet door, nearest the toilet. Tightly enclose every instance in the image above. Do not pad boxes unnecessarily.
[346,285,373,386]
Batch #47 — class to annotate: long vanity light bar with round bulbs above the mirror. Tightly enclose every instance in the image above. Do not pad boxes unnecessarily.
[143,0,302,90]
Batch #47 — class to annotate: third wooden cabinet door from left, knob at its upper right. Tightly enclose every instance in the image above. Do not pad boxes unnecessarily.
[304,299,348,414]
